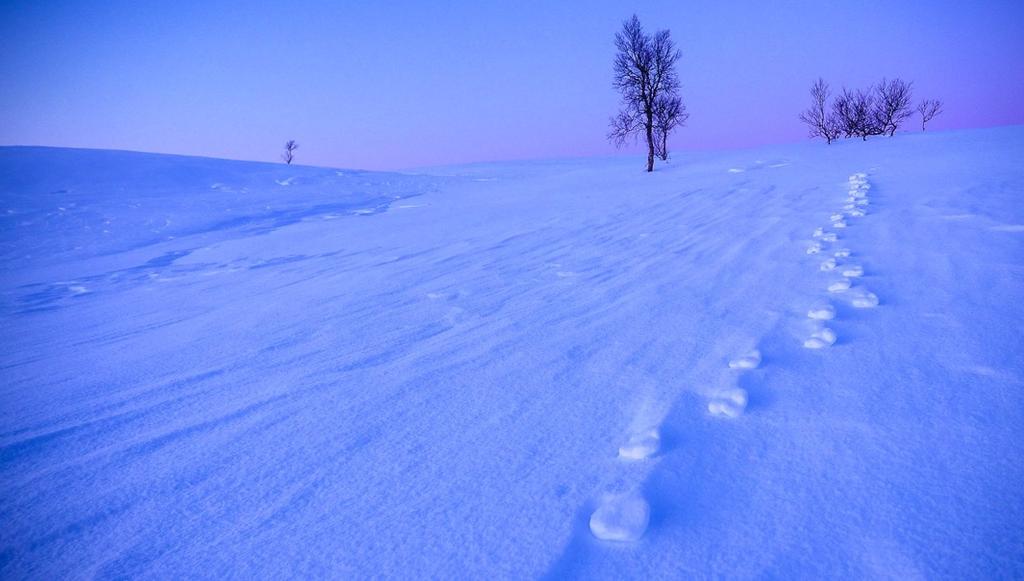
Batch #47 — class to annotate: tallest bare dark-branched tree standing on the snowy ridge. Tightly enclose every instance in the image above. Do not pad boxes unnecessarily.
[608,14,681,171]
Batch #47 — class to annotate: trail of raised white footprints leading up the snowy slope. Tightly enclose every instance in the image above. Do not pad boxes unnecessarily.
[590,173,879,541]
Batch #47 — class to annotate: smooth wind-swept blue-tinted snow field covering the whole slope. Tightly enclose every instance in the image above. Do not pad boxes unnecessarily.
[0,127,1024,579]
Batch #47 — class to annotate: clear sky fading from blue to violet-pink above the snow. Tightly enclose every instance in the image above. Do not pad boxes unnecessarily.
[0,0,1024,169]
